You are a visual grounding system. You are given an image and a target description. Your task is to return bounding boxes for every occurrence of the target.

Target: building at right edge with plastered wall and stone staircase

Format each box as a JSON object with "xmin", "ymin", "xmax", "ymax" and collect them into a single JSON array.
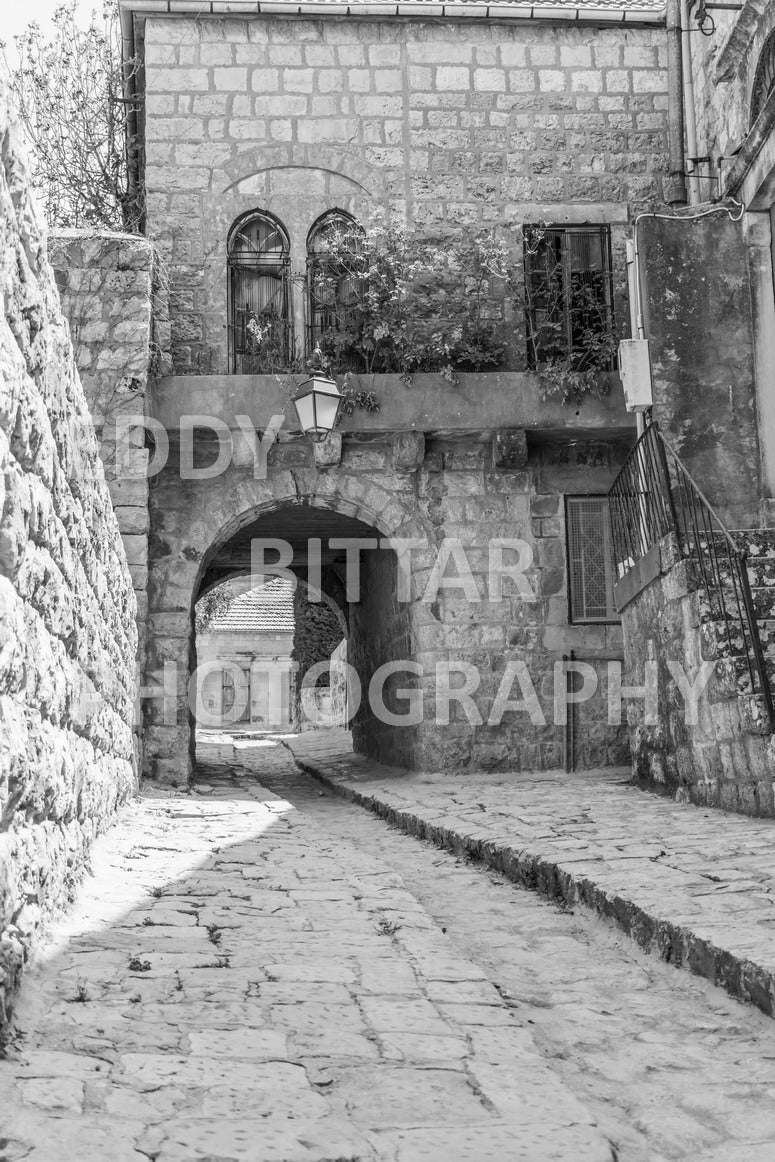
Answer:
[{"xmin": 616, "ymin": 0, "xmax": 775, "ymax": 815}]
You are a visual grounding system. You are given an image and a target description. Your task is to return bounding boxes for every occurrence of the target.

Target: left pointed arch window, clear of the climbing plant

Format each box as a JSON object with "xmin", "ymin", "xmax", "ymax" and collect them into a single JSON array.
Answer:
[{"xmin": 228, "ymin": 213, "xmax": 293, "ymax": 375}]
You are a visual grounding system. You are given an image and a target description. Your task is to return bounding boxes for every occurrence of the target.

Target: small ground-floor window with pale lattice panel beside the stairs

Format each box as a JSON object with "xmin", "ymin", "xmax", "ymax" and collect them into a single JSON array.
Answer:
[{"xmin": 565, "ymin": 496, "xmax": 618, "ymax": 624}]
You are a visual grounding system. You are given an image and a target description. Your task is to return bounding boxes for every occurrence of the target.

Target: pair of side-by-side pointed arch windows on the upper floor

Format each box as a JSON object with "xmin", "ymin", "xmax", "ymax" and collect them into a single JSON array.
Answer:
[{"xmin": 228, "ymin": 210, "xmax": 361, "ymax": 375}]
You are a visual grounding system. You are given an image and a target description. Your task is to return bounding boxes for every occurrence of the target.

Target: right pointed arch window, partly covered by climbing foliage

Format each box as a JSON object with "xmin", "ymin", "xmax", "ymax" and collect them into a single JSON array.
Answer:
[{"xmin": 307, "ymin": 210, "xmax": 367, "ymax": 371}]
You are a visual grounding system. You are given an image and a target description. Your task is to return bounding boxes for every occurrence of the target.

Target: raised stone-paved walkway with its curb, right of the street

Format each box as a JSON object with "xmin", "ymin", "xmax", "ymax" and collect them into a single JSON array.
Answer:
[{"xmin": 285, "ymin": 731, "xmax": 775, "ymax": 1016}]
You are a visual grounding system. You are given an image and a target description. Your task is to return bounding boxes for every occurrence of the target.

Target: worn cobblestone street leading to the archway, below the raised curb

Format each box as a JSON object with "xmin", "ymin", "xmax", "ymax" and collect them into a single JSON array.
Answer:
[{"xmin": 0, "ymin": 740, "xmax": 775, "ymax": 1162}]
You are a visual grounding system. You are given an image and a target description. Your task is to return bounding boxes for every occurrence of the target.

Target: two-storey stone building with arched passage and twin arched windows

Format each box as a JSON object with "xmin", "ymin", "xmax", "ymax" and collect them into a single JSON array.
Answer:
[{"xmin": 112, "ymin": 0, "xmax": 680, "ymax": 782}]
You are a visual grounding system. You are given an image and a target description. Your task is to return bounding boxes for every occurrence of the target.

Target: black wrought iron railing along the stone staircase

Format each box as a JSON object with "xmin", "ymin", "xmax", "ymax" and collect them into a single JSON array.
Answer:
[{"xmin": 609, "ymin": 424, "xmax": 775, "ymax": 724}]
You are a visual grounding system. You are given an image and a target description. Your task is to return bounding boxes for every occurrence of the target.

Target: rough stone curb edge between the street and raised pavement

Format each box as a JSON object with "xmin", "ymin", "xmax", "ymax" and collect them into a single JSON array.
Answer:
[{"xmin": 286, "ymin": 744, "xmax": 775, "ymax": 1017}]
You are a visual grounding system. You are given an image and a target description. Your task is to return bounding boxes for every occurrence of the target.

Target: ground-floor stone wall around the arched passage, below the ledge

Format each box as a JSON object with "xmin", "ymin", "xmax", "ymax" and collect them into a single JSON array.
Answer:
[{"xmin": 145, "ymin": 433, "xmax": 626, "ymax": 783}]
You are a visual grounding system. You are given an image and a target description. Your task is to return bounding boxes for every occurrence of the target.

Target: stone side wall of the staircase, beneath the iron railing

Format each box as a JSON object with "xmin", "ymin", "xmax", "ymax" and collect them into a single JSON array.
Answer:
[{"xmin": 623, "ymin": 538, "xmax": 775, "ymax": 816}]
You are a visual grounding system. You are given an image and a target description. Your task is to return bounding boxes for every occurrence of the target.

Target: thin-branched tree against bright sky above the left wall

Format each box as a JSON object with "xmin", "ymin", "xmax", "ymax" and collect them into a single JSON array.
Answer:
[{"xmin": 2, "ymin": 0, "xmax": 141, "ymax": 232}]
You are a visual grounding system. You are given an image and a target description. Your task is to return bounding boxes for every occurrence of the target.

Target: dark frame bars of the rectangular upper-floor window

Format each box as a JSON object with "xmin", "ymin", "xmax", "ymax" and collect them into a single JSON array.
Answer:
[{"xmin": 523, "ymin": 222, "xmax": 615, "ymax": 371}]
